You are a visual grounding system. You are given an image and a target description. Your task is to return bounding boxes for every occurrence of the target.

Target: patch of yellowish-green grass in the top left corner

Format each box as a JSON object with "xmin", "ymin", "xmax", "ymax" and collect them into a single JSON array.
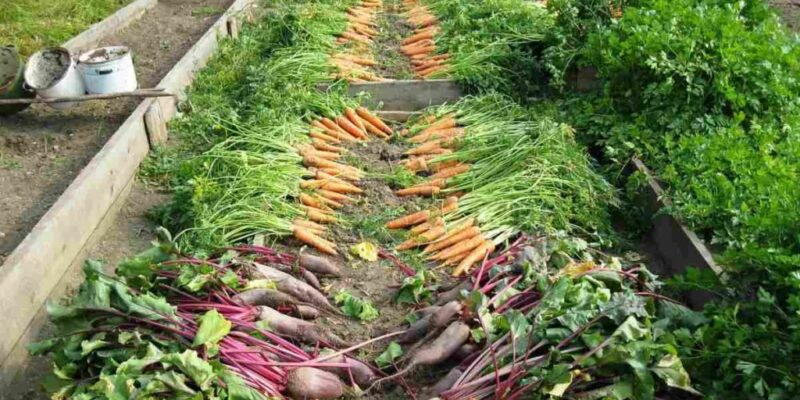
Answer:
[{"xmin": 0, "ymin": 0, "xmax": 132, "ymax": 57}]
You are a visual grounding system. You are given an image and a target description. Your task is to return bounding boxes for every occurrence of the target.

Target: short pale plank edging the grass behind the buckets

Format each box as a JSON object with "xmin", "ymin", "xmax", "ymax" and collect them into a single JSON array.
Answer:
[{"xmin": 63, "ymin": 0, "xmax": 158, "ymax": 53}]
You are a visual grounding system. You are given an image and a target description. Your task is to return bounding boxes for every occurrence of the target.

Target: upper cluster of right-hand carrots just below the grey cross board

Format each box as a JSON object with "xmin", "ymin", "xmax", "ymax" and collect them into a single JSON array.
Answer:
[{"xmin": 395, "ymin": 114, "xmax": 470, "ymax": 196}]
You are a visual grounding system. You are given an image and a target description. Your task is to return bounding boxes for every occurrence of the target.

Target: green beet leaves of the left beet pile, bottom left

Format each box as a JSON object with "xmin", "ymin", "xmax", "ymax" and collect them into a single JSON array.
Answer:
[{"xmin": 29, "ymin": 261, "xmax": 265, "ymax": 400}]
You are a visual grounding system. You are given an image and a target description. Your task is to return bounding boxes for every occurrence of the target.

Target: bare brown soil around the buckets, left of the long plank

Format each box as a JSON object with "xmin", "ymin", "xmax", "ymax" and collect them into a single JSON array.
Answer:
[{"xmin": 0, "ymin": 0, "xmax": 232, "ymax": 264}]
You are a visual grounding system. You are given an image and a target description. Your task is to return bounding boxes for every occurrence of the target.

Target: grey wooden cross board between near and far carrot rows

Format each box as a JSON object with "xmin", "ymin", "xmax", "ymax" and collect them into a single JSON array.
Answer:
[{"xmin": 320, "ymin": 79, "xmax": 462, "ymax": 111}]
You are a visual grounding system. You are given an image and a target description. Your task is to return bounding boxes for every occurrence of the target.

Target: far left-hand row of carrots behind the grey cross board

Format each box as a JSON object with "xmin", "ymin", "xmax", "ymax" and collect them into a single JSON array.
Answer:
[{"xmin": 330, "ymin": 0, "xmax": 387, "ymax": 82}]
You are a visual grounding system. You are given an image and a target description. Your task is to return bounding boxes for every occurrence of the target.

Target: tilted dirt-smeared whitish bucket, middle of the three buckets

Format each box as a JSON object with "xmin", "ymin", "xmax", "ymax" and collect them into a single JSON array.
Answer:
[{"xmin": 25, "ymin": 47, "xmax": 86, "ymax": 110}]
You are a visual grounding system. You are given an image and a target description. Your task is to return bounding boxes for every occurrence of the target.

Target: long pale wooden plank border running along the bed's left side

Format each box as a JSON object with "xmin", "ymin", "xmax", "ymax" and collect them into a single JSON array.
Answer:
[{"xmin": 0, "ymin": 0, "xmax": 256, "ymax": 393}]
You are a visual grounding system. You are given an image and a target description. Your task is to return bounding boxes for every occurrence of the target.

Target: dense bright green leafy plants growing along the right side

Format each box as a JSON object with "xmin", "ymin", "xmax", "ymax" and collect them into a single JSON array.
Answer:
[{"xmin": 546, "ymin": 0, "xmax": 800, "ymax": 399}]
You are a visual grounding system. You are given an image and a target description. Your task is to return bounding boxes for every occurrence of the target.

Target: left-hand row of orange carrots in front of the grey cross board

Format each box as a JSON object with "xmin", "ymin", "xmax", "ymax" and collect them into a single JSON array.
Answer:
[{"xmin": 292, "ymin": 107, "xmax": 392, "ymax": 255}]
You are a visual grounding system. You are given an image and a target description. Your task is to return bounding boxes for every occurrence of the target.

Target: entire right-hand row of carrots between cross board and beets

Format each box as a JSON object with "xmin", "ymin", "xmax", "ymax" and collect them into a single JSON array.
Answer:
[{"xmin": 386, "ymin": 114, "xmax": 494, "ymax": 276}]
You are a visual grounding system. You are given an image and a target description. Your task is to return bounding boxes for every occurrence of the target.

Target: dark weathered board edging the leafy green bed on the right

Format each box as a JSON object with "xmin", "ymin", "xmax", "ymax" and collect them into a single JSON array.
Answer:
[{"xmin": 632, "ymin": 158, "xmax": 724, "ymax": 309}]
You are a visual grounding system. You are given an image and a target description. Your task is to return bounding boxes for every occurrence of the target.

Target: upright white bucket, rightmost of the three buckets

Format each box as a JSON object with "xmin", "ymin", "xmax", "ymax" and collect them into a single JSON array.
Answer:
[{"xmin": 78, "ymin": 46, "xmax": 138, "ymax": 94}]
